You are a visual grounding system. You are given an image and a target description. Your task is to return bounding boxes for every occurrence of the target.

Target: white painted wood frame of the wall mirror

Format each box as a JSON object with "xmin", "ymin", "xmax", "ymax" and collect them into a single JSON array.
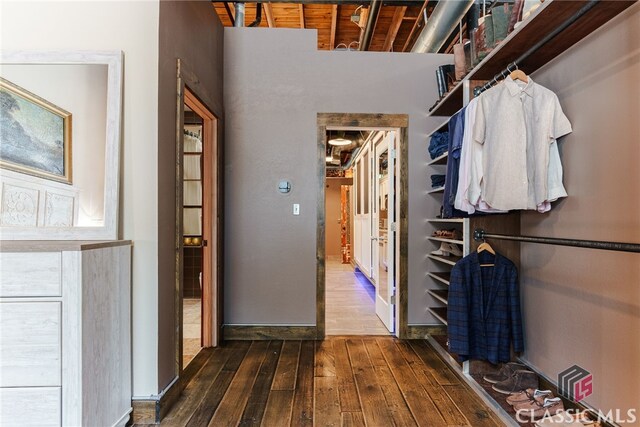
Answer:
[{"xmin": 0, "ymin": 51, "xmax": 124, "ymax": 240}]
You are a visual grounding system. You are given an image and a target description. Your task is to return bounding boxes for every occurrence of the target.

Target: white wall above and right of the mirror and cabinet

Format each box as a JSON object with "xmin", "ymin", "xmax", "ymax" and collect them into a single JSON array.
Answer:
[{"xmin": 0, "ymin": 1, "xmax": 159, "ymax": 396}]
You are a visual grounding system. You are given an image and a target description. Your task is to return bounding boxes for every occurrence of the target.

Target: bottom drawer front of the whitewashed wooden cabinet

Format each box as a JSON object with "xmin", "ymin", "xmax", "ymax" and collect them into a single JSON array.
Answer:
[{"xmin": 0, "ymin": 387, "xmax": 62, "ymax": 427}]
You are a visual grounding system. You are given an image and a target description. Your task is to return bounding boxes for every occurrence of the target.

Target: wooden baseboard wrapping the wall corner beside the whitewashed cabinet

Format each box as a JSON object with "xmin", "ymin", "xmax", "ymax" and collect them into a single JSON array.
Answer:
[{"xmin": 131, "ymin": 348, "xmax": 213, "ymax": 424}]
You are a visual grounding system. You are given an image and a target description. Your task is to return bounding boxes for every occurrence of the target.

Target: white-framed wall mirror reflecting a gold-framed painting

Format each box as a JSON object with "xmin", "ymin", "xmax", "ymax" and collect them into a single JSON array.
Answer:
[{"xmin": 0, "ymin": 51, "xmax": 123, "ymax": 240}]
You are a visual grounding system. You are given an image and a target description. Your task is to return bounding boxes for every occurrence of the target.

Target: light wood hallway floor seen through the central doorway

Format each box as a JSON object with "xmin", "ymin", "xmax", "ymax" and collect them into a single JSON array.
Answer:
[{"xmin": 325, "ymin": 257, "xmax": 389, "ymax": 335}]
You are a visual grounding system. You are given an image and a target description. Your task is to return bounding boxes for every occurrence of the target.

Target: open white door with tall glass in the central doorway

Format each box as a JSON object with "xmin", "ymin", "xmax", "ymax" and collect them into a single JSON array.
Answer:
[{"xmin": 371, "ymin": 132, "xmax": 396, "ymax": 333}]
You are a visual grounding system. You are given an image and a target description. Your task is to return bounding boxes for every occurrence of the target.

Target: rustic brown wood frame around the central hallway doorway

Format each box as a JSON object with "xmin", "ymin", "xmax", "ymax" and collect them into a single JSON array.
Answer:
[{"xmin": 316, "ymin": 113, "xmax": 409, "ymax": 339}]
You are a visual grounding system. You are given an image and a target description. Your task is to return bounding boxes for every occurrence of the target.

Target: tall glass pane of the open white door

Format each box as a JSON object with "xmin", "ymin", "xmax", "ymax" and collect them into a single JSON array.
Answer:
[{"xmin": 374, "ymin": 151, "xmax": 389, "ymax": 303}]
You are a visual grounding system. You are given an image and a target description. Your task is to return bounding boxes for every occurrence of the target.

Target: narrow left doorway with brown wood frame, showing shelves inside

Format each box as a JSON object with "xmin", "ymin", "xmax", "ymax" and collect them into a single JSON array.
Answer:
[{"xmin": 176, "ymin": 85, "xmax": 220, "ymax": 372}]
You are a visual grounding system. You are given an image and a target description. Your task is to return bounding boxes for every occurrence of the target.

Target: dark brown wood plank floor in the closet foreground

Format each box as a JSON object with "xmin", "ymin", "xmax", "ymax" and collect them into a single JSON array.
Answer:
[{"xmin": 145, "ymin": 336, "xmax": 502, "ymax": 427}]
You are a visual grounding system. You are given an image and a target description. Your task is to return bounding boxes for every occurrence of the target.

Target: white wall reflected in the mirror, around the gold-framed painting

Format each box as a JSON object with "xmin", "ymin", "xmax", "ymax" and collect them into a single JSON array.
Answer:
[{"xmin": 0, "ymin": 64, "xmax": 107, "ymax": 226}]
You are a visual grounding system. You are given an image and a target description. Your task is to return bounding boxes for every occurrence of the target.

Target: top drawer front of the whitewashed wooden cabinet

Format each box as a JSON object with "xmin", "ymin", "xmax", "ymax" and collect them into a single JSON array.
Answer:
[{"xmin": 0, "ymin": 252, "xmax": 62, "ymax": 297}]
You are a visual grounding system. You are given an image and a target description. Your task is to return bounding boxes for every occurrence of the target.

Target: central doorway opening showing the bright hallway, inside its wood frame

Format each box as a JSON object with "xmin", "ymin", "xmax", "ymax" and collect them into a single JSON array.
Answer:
[{"xmin": 325, "ymin": 129, "xmax": 398, "ymax": 335}]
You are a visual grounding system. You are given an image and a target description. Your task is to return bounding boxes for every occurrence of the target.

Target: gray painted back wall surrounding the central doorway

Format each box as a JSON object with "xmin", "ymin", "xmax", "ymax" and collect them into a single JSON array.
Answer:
[{"xmin": 224, "ymin": 28, "xmax": 451, "ymax": 325}]
